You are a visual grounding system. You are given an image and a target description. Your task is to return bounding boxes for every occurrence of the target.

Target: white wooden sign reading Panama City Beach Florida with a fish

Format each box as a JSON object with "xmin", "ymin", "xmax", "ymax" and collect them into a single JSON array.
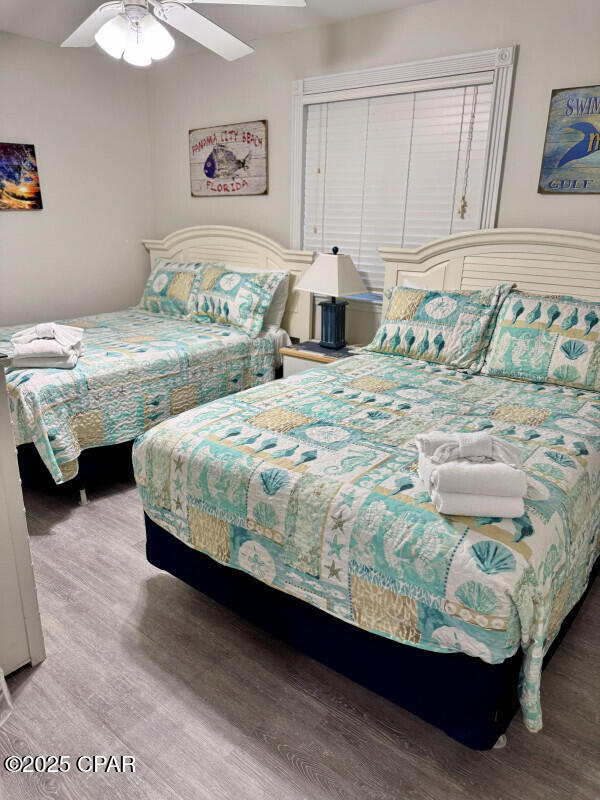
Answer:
[{"xmin": 189, "ymin": 119, "xmax": 269, "ymax": 197}]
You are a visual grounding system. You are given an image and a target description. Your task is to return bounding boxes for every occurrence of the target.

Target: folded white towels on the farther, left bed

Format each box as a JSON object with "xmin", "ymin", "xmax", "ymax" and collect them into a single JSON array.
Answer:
[{"xmin": 11, "ymin": 322, "xmax": 83, "ymax": 369}]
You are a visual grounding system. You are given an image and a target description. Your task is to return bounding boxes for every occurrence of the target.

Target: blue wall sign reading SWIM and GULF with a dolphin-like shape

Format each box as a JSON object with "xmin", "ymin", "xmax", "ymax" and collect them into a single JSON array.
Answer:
[{"xmin": 538, "ymin": 86, "xmax": 600, "ymax": 194}]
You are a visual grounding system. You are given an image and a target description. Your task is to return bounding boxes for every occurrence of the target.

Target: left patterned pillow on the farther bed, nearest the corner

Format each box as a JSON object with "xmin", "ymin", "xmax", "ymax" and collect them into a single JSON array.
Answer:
[{"xmin": 139, "ymin": 258, "xmax": 203, "ymax": 317}]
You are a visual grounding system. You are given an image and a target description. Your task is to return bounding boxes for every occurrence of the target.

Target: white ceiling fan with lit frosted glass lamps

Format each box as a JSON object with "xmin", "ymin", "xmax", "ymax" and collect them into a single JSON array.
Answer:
[{"xmin": 61, "ymin": 0, "xmax": 306, "ymax": 67}]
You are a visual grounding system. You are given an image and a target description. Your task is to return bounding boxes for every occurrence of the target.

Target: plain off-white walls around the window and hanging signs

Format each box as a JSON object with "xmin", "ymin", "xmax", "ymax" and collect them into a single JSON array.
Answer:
[{"xmin": 0, "ymin": 0, "xmax": 600, "ymax": 332}]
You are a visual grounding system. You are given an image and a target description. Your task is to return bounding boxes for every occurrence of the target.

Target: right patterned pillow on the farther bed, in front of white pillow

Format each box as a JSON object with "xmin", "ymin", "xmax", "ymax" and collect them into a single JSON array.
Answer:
[{"xmin": 194, "ymin": 264, "xmax": 289, "ymax": 335}]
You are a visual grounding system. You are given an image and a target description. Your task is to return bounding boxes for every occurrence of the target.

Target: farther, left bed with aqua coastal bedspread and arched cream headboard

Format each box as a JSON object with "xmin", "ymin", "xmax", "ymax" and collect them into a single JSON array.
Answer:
[{"xmin": 0, "ymin": 226, "xmax": 313, "ymax": 483}]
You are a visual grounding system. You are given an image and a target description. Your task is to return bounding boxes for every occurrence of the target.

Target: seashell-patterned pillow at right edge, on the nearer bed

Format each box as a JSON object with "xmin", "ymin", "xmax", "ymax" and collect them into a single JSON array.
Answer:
[{"xmin": 483, "ymin": 292, "xmax": 600, "ymax": 391}]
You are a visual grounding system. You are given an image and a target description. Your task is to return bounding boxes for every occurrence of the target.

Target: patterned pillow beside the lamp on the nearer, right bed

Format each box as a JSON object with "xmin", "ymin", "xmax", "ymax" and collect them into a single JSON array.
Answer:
[{"xmin": 366, "ymin": 283, "xmax": 514, "ymax": 372}]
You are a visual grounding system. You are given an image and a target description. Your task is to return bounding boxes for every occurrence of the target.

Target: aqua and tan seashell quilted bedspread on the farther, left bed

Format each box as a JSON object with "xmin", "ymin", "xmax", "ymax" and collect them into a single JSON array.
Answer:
[{"xmin": 0, "ymin": 309, "xmax": 274, "ymax": 483}]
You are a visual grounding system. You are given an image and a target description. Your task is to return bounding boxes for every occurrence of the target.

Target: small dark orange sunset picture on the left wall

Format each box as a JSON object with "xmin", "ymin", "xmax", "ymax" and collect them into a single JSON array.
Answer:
[{"xmin": 0, "ymin": 142, "xmax": 42, "ymax": 211}]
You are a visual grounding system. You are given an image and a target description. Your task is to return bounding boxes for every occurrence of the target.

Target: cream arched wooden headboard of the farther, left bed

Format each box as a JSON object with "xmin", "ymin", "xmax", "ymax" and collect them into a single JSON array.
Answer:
[{"xmin": 144, "ymin": 225, "xmax": 314, "ymax": 341}]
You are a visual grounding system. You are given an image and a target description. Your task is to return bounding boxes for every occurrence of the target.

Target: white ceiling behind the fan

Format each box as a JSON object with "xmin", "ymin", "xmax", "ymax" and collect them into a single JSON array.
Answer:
[{"xmin": 0, "ymin": 0, "xmax": 431, "ymax": 55}]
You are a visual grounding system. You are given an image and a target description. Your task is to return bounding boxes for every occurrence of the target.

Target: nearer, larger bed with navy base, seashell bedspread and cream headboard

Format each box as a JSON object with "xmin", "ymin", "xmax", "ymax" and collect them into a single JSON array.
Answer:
[{"xmin": 134, "ymin": 230, "xmax": 600, "ymax": 749}]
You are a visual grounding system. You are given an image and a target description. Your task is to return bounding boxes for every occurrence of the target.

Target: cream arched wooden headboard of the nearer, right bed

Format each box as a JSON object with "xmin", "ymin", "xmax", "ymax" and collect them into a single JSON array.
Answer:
[{"xmin": 379, "ymin": 228, "xmax": 600, "ymax": 313}]
